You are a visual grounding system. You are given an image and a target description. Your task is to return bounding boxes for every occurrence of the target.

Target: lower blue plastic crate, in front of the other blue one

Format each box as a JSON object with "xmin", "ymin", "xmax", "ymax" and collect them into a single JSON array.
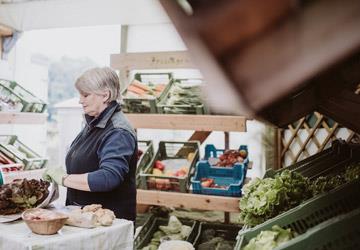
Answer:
[{"xmin": 191, "ymin": 161, "xmax": 246, "ymax": 197}]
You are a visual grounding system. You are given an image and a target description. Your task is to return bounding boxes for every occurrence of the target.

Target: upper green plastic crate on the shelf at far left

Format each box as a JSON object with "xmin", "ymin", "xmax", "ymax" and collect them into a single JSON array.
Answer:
[{"xmin": 0, "ymin": 79, "xmax": 46, "ymax": 113}]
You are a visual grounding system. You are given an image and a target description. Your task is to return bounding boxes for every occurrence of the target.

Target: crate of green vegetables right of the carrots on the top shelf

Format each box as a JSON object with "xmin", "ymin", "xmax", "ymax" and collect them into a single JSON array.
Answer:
[{"xmin": 157, "ymin": 79, "xmax": 207, "ymax": 114}]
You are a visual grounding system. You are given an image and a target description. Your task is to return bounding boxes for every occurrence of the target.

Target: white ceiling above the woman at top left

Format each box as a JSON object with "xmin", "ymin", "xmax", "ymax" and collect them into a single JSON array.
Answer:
[{"xmin": 0, "ymin": 0, "xmax": 170, "ymax": 31}]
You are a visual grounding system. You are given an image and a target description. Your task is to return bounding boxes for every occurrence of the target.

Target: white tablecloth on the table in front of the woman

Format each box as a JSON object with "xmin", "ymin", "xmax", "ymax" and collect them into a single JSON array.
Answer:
[{"xmin": 0, "ymin": 219, "xmax": 134, "ymax": 250}]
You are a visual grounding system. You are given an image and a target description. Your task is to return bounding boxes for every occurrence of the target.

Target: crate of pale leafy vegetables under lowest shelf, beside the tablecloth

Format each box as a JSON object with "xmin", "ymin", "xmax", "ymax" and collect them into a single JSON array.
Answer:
[{"xmin": 134, "ymin": 215, "xmax": 199, "ymax": 250}]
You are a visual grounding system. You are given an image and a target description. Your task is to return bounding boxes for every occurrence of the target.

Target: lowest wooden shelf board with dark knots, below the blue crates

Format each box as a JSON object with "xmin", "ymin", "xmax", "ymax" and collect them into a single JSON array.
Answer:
[{"xmin": 137, "ymin": 189, "xmax": 240, "ymax": 212}]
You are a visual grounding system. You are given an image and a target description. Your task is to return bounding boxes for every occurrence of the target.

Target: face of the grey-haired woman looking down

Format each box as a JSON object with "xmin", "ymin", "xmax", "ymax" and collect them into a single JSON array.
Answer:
[{"xmin": 79, "ymin": 92, "xmax": 108, "ymax": 117}]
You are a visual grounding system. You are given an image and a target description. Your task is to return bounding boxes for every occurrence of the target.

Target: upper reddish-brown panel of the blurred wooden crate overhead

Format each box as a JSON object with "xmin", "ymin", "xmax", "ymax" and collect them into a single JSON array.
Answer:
[{"xmin": 188, "ymin": 0, "xmax": 295, "ymax": 57}]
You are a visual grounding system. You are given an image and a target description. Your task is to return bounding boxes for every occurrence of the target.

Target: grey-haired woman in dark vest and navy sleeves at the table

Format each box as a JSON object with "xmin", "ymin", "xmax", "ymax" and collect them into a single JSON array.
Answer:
[{"xmin": 44, "ymin": 67, "xmax": 137, "ymax": 221}]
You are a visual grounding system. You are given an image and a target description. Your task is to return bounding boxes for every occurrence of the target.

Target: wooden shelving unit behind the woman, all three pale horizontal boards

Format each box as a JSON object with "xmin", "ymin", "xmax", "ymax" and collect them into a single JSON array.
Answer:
[{"xmin": 110, "ymin": 51, "xmax": 247, "ymax": 215}]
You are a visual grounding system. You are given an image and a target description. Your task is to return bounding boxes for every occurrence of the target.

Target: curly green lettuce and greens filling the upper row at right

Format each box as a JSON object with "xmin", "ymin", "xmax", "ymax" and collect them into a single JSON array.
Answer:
[{"xmin": 240, "ymin": 163, "xmax": 360, "ymax": 226}]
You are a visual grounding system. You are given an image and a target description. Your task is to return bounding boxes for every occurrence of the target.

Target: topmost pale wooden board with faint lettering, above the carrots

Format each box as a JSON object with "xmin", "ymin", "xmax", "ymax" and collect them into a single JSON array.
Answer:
[{"xmin": 110, "ymin": 51, "xmax": 195, "ymax": 70}]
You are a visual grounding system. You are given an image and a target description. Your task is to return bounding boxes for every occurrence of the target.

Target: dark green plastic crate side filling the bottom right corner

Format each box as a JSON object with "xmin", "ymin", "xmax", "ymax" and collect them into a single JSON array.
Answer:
[{"xmin": 276, "ymin": 208, "xmax": 360, "ymax": 250}]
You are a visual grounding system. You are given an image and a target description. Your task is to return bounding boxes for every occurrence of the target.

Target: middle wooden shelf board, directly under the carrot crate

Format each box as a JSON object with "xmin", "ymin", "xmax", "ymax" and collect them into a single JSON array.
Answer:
[{"xmin": 126, "ymin": 114, "xmax": 246, "ymax": 132}]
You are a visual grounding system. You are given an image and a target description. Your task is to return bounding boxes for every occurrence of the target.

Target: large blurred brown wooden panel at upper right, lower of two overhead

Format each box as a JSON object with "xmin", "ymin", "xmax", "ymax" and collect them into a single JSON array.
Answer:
[{"xmin": 228, "ymin": 0, "xmax": 360, "ymax": 110}]
